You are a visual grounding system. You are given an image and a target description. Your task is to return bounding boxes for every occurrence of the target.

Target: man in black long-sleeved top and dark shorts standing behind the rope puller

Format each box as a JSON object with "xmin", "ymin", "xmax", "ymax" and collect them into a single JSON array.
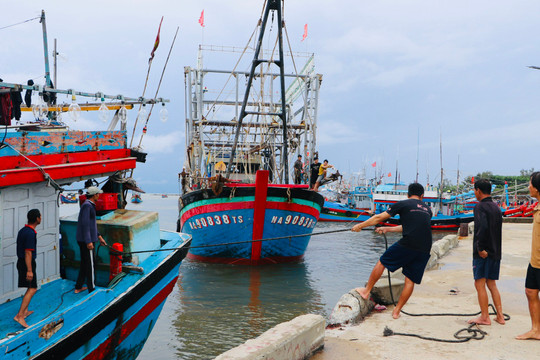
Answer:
[{"xmin": 469, "ymin": 179, "xmax": 505, "ymax": 325}]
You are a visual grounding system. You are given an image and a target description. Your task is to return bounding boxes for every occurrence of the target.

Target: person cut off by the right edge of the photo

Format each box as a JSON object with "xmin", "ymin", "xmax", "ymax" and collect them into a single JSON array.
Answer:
[{"xmin": 516, "ymin": 171, "xmax": 540, "ymax": 340}]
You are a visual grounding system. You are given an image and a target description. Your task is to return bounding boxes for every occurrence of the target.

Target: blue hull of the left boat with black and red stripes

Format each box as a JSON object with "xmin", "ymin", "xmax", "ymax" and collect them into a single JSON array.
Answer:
[{"xmin": 0, "ymin": 235, "xmax": 190, "ymax": 359}]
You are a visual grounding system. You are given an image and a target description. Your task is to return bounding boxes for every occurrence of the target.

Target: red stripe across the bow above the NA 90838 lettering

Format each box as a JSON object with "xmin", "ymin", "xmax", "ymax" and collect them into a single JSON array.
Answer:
[{"xmin": 180, "ymin": 201, "xmax": 319, "ymax": 226}]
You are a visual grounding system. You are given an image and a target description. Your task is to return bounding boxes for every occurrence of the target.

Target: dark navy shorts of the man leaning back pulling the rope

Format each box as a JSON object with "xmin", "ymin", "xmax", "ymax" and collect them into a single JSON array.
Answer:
[{"xmin": 379, "ymin": 243, "xmax": 431, "ymax": 284}]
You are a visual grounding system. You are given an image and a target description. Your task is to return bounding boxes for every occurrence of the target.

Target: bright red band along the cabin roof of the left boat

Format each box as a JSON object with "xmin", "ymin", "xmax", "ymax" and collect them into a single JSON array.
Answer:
[{"xmin": 0, "ymin": 158, "xmax": 136, "ymax": 187}]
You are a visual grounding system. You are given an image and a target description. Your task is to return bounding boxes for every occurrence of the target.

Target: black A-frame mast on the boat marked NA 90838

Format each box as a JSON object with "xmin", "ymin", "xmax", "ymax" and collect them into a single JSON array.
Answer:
[{"xmin": 225, "ymin": 0, "xmax": 289, "ymax": 184}]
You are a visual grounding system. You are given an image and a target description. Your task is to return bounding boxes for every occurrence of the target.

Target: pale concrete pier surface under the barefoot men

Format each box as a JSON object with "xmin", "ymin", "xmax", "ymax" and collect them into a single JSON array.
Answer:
[{"xmin": 311, "ymin": 222, "xmax": 540, "ymax": 360}]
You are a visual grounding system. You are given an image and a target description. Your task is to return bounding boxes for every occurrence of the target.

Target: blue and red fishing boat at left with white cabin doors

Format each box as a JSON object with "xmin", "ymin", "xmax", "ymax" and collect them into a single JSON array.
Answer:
[{"xmin": 0, "ymin": 12, "xmax": 190, "ymax": 360}]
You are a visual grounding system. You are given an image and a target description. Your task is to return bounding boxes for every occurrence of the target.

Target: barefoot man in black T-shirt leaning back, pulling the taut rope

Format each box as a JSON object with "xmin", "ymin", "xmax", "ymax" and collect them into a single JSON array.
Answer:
[{"xmin": 352, "ymin": 183, "xmax": 432, "ymax": 319}]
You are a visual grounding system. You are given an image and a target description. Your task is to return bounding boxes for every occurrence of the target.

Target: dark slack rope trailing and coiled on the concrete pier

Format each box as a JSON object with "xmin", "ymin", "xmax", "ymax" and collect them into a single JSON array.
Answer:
[{"xmin": 382, "ymin": 233, "xmax": 510, "ymax": 343}]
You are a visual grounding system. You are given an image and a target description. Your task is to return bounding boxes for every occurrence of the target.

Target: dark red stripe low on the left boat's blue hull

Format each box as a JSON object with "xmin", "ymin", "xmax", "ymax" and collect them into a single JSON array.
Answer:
[{"xmin": 84, "ymin": 276, "xmax": 178, "ymax": 360}]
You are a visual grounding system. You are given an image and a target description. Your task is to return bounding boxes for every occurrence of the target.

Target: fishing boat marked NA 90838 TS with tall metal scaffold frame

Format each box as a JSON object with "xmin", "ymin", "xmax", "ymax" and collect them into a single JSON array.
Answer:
[{"xmin": 177, "ymin": 0, "xmax": 324, "ymax": 265}]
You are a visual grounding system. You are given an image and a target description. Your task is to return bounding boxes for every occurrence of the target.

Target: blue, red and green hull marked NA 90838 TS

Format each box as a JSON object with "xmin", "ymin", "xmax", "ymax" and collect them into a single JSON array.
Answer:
[{"xmin": 178, "ymin": 186, "xmax": 324, "ymax": 265}]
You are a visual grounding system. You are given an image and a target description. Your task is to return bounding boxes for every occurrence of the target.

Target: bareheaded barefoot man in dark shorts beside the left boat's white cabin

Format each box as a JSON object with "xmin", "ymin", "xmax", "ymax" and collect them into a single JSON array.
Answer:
[{"xmin": 13, "ymin": 209, "xmax": 41, "ymax": 328}]
